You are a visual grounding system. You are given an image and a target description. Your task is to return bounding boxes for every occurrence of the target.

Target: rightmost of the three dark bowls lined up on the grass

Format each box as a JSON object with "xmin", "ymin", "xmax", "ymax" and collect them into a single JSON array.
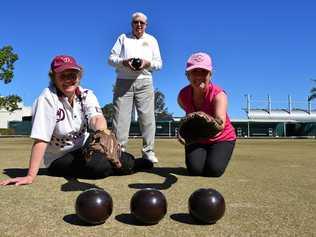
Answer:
[{"xmin": 189, "ymin": 188, "xmax": 225, "ymax": 224}]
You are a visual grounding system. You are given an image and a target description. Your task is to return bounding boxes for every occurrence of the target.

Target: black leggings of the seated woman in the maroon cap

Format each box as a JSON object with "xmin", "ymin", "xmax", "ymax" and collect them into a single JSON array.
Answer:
[{"xmin": 48, "ymin": 149, "xmax": 135, "ymax": 179}]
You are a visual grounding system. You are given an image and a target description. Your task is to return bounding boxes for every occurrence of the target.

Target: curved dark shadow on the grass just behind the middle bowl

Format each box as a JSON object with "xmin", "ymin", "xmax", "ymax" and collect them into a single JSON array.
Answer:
[{"xmin": 128, "ymin": 167, "xmax": 188, "ymax": 190}]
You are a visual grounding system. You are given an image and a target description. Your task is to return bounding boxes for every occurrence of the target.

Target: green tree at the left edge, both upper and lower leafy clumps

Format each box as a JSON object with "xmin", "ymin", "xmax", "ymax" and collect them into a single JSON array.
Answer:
[{"xmin": 0, "ymin": 46, "xmax": 22, "ymax": 112}]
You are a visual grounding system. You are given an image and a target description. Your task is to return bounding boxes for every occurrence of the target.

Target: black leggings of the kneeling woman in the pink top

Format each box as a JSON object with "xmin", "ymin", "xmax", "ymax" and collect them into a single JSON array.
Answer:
[{"xmin": 185, "ymin": 141, "xmax": 235, "ymax": 177}]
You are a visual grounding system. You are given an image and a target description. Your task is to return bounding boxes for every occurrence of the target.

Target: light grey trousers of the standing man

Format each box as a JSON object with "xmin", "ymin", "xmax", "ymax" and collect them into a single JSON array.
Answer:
[{"xmin": 113, "ymin": 79, "xmax": 156, "ymax": 152}]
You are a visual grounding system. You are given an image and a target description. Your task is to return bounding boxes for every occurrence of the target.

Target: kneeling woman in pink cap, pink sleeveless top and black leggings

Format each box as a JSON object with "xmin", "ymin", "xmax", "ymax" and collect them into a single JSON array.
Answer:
[{"xmin": 178, "ymin": 52, "xmax": 236, "ymax": 177}]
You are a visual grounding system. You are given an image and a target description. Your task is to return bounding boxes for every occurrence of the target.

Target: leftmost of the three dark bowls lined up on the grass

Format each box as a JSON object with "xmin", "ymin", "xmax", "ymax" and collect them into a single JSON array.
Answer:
[{"xmin": 75, "ymin": 188, "xmax": 113, "ymax": 225}]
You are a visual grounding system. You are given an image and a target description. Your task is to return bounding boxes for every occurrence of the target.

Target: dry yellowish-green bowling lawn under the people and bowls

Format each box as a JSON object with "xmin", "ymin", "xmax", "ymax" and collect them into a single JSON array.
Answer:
[{"xmin": 0, "ymin": 138, "xmax": 316, "ymax": 237}]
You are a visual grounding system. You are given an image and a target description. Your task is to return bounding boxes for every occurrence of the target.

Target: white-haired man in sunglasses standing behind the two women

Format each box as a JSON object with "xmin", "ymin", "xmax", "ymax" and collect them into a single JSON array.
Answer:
[{"xmin": 109, "ymin": 12, "xmax": 162, "ymax": 163}]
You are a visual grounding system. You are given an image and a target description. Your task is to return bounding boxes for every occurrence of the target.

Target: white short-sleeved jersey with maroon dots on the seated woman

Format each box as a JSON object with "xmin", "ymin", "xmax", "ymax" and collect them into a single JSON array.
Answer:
[{"xmin": 31, "ymin": 85, "xmax": 102, "ymax": 167}]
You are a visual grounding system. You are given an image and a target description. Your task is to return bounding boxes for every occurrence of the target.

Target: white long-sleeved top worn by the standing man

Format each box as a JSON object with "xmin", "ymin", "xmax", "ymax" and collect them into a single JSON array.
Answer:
[{"xmin": 109, "ymin": 33, "xmax": 162, "ymax": 80}]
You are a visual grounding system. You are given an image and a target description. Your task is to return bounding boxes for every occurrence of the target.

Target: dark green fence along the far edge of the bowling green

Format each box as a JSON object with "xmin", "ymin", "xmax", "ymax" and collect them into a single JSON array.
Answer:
[{"xmin": 4, "ymin": 121, "xmax": 316, "ymax": 137}]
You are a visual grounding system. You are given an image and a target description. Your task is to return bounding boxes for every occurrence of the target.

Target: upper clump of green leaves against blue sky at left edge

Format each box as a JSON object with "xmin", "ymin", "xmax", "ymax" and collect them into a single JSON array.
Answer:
[{"xmin": 0, "ymin": 46, "xmax": 19, "ymax": 84}]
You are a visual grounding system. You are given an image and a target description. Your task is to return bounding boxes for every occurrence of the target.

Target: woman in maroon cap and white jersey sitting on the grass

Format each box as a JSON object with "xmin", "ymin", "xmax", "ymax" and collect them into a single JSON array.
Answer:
[{"xmin": 0, "ymin": 55, "xmax": 151, "ymax": 185}]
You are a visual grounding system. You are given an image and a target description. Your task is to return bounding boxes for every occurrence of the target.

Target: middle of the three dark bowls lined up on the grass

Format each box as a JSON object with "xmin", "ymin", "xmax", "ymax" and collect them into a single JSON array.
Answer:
[{"xmin": 130, "ymin": 189, "xmax": 167, "ymax": 225}]
